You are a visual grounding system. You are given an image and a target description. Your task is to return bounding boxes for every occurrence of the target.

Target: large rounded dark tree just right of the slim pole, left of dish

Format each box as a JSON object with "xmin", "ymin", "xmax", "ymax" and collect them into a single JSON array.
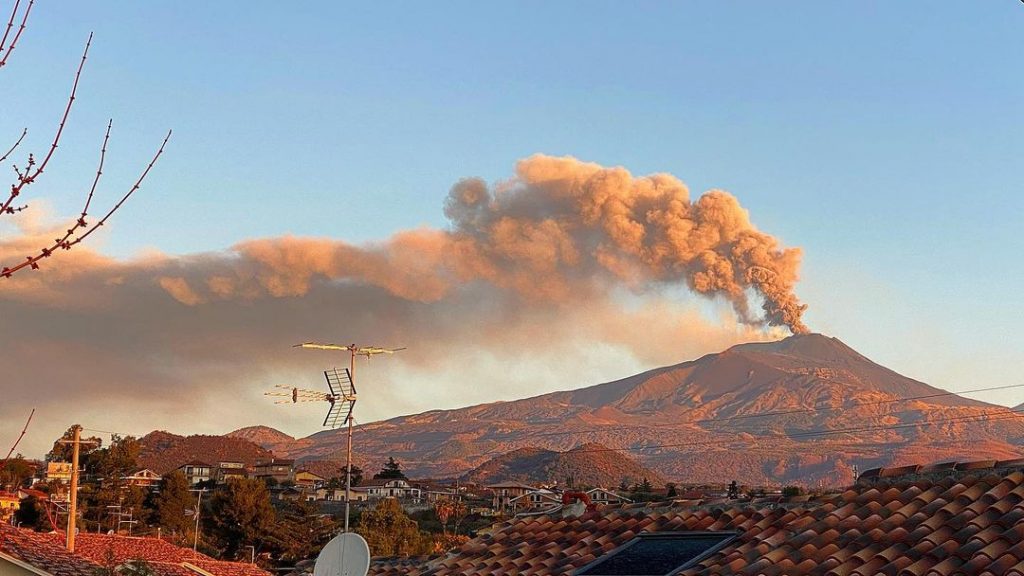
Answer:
[{"xmin": 203, "ymin": 478, "xmax": 278, "ymax": 558}]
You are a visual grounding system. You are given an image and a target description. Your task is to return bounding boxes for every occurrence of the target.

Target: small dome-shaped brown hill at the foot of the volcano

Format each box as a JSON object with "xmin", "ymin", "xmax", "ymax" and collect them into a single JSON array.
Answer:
[{"xmin": 464, "ymin": 444, "xmax": 666, "ymax": 488}]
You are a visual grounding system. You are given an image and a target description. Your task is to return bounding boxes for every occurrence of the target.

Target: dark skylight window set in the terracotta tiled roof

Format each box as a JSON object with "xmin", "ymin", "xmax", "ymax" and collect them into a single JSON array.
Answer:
[{"xmin": 575, "ymin": 532, "xmax": 736, "ymax": 576}]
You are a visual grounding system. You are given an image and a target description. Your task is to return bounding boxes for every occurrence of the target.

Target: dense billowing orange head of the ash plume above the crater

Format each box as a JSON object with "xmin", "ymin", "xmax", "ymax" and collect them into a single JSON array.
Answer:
[{"xmin": 444, "ymin": 156, "xmax": 808, "ymax": 333}]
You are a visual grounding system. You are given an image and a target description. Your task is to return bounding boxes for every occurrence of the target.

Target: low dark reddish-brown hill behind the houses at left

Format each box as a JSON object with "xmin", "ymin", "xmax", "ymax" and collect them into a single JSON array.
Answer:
[{"xmin": 138, "ymin": 430, "xmax": 273, "ymax": 475}]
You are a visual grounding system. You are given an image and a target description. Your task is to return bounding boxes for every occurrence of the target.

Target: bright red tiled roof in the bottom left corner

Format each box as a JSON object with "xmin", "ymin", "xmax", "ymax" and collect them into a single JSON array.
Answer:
[{"xmin": 0, "ymin": 525, "xmax": 269, "ymax": 576}]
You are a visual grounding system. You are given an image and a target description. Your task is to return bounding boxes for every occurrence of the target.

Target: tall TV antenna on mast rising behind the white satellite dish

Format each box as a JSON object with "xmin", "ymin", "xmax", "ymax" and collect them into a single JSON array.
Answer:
[{"xmin": 274, "ymin": 342, "xmax": 406, "ymax": 532}]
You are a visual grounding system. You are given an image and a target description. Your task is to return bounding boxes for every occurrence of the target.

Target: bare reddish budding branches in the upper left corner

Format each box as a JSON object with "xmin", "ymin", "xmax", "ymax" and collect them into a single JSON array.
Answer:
[{"xmin": 0, "ymin": 1, "xmax": 171, "ymax": 279}]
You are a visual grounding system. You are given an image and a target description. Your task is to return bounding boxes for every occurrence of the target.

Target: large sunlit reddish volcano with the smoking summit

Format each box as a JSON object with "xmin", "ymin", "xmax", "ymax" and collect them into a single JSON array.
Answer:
[{"xmin": 251, "ymin": 334, "xmax": 1024, "ymax": 485}]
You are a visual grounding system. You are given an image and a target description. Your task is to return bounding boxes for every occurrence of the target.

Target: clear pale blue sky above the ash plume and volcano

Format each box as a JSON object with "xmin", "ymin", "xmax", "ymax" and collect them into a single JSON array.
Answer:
[{"xmin": 0, "ymin": 0, "xmax": 1024, "ymax": 453}]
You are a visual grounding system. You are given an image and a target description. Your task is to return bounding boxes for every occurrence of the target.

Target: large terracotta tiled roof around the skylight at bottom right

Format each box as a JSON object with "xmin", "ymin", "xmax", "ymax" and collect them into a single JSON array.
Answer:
[{"xmin": 371, "ymin": 457, "xmax": 1024, "ymax": 576}]
